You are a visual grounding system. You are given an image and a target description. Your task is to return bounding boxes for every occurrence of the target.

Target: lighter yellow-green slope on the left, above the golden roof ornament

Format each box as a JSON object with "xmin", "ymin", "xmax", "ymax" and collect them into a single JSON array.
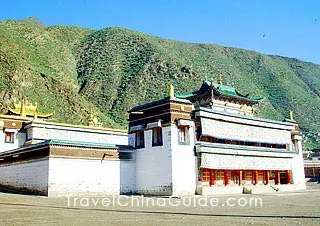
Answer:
[{"xmin": 0, "ymin": 20, "xmax": 118, "ymax": 127}]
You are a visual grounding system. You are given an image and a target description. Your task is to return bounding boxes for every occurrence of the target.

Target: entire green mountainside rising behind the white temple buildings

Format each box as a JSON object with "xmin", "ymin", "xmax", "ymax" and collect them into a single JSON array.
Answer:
[{"xmin": 0, "ymin": 18, "xmax": 320, "ymax": 147}]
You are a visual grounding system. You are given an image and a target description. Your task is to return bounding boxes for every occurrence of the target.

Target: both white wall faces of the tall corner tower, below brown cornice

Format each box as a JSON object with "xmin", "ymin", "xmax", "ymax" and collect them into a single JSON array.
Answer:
[{"xmin": 131, "ymin": 125, "xmax": 197, "ymax": 196}]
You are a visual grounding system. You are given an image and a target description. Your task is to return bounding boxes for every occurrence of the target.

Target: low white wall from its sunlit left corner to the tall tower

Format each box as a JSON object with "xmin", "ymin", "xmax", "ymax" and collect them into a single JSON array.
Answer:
[{"xmin": 49, "ymin": 157, "xmax": 135, "ymax": 197}]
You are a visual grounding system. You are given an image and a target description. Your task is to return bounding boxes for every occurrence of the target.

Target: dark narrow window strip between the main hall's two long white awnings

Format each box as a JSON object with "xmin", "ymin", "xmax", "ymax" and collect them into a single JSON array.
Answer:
[{"xmin": 200, "ymin": 136, "xmax": 288, "ymax": 149}]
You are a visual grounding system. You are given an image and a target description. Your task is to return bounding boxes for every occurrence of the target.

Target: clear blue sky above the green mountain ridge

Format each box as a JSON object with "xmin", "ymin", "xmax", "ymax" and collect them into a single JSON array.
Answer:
[{"xmin": 0, "ymin": 0, "xmax": 320, "ymax": 64}]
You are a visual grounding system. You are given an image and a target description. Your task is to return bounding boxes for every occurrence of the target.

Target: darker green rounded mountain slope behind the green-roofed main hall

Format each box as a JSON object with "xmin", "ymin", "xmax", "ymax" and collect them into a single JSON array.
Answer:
[{"xmin": 77, "ymin": 28, "xmax": 320, "ymax": 134}]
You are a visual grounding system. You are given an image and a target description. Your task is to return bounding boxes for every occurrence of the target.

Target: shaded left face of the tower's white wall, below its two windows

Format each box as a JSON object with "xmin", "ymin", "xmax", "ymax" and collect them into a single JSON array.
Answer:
[{"xmin": 135, "ymin": 127, "xmax": 172, "ymax": 195}]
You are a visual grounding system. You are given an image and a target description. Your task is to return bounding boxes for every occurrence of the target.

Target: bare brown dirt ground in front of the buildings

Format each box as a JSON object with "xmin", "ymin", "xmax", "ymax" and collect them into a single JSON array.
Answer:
[{"xmin": 0, "ymin": 184, "xmax": 320, "ymax": 226}]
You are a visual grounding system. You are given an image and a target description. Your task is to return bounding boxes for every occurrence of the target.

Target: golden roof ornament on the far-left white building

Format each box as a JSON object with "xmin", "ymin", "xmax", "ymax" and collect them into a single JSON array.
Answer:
[{"xmin": 8, "ymin": 98, "xmax": 53, "ymax": 119}]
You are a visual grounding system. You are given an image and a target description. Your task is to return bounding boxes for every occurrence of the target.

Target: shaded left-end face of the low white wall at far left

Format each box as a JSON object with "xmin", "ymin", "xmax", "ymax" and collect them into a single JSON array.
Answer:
[{"xmin": 0, "ymin": 159, "xmax": 49, "ymax": 194}]
